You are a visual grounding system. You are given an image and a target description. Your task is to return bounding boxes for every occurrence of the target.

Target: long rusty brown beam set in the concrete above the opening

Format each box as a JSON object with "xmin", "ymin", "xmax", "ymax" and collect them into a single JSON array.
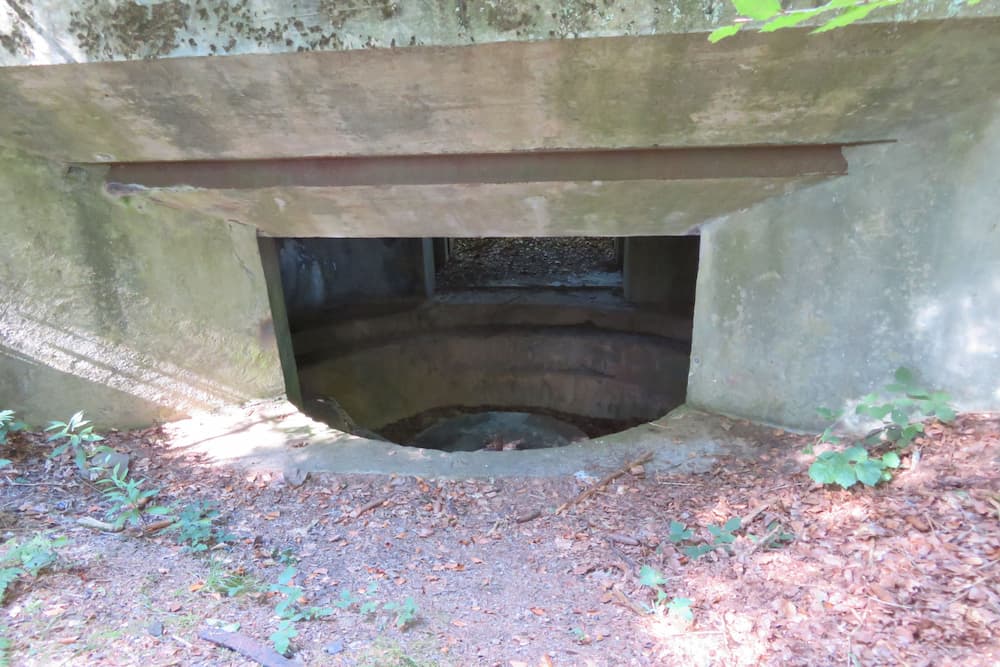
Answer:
[{"xmin": 106, "ymin": 145, "xmax": 847, "ymax": 189}]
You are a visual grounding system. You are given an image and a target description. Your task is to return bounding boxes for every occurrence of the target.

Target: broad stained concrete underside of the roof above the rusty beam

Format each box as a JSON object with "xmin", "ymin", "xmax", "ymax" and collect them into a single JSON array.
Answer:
[{"xmin": 0, "ymin": 20, "xmax": 1000, "ymax": 162}]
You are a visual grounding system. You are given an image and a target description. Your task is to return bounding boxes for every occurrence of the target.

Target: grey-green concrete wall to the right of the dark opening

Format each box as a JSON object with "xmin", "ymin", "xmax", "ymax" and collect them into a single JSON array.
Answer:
[{"xmin": 688, "ymin": 104, "xmax": 1000, "ymax": 428}]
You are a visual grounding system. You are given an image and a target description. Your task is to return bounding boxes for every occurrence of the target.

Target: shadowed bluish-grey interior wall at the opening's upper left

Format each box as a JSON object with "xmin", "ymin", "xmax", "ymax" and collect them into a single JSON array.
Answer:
[{"xmin": 277, "ymin": 238, "xmax": 428, "ymax": 327}]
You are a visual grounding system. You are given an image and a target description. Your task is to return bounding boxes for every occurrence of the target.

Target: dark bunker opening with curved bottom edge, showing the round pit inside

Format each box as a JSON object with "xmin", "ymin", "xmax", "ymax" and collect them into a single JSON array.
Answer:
[{"xmin": 277, "ymin": 236, "xmax": 699, "ymax": 451}]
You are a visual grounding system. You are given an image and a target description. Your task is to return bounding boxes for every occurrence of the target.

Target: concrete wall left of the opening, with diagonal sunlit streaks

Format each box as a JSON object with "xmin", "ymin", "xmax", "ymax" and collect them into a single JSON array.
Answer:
[{"xmin": 0, "ymin": 150, "xmax": 283, "ymax": 426}]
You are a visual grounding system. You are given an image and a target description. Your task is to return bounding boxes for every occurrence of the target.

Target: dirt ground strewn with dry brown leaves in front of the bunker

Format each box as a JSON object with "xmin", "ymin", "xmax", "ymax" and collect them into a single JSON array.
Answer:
[{"xmin": 0, "ymin": 415, "xmax": 1000, "ymax": 667}]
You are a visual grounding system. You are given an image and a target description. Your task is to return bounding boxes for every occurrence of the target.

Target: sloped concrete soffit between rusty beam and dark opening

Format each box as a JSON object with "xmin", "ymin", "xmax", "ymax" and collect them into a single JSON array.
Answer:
[{"xmin": 128, "ymin": 176, "xmax": 839, "ymax": 237}]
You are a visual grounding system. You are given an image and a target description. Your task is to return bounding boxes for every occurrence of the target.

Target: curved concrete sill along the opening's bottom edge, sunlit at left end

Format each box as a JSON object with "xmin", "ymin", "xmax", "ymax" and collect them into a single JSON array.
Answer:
[{"xmin": 164, "ymin": 401, "xmax": 769, "ymax": 484}]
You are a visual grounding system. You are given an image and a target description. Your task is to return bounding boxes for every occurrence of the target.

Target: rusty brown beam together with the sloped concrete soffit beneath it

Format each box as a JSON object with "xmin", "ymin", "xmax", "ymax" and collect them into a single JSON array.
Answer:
[{"xmin": 106, "ymin": 146, "xmax": 847, "ymax": 237}]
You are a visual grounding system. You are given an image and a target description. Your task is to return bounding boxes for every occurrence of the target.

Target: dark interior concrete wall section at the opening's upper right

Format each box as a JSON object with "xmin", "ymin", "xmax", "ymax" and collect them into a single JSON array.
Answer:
[{"xmin": 622, "ymin": 236, "xmax": 700, "ymax": 312}]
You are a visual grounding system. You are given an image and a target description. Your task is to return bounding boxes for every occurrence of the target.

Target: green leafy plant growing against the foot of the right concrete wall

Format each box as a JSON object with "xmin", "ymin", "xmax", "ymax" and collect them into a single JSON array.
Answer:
[{"xmin": 809, "ymin": 368, "xmax": 955, "ymax": 489}]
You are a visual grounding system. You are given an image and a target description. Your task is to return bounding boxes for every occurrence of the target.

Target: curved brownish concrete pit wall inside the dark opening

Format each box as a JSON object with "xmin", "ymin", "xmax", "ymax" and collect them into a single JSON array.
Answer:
[{"xmin": 295, "ymin": 293, "xmax": 691, "ymax": 448}]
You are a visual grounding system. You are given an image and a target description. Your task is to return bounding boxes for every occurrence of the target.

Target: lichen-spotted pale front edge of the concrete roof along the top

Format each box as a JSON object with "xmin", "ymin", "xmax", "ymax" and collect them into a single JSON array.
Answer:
[{"xmin": 0, "ymin": 0, "xmax": 996, "ymax": 65}]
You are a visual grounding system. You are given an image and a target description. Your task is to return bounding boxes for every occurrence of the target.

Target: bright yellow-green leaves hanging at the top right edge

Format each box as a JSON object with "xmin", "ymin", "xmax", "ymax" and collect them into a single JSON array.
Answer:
[{"xmin": 708, "ymin": 0, "xmax": 981, "ymax": 43}]
